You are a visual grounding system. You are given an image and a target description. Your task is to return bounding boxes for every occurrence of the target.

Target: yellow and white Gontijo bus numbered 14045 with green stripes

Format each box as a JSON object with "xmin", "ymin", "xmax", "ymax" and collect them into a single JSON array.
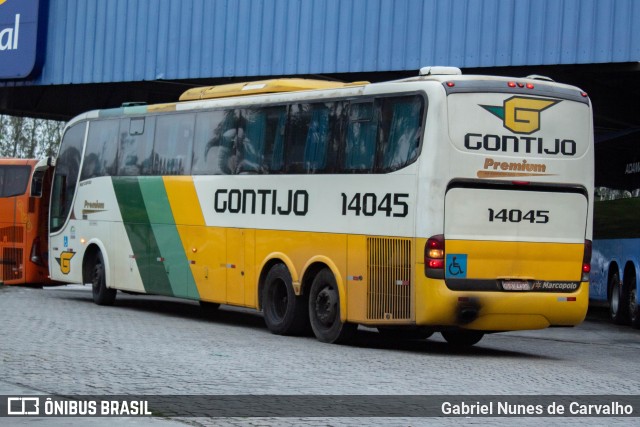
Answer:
[{"xmin": 49, "ymin": 67, "xmax": 593, "ymax": 345}]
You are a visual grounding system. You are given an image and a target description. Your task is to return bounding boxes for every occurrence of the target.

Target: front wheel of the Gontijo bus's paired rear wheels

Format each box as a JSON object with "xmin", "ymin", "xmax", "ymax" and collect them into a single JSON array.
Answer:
[{"xmin": 263, "ymin": 264, "xmax": 309, "ymax": 335}]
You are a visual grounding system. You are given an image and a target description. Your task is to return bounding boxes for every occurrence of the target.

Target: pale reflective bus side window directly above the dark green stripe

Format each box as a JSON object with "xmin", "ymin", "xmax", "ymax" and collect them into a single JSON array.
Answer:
[{"xmin": 118, "ymin": 117, "xmax": 156, "ymax": 176}]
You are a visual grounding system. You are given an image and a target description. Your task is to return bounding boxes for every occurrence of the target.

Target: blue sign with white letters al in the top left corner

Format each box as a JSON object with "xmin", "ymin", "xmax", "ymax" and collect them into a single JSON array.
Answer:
[{"xmin": 0, "ymin": 0, "xmax": 40, "ymax": 79}]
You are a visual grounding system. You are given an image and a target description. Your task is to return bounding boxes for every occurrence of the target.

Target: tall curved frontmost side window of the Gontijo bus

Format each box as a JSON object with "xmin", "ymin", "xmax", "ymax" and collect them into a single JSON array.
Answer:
[{"xmin": 50, "ymin": 123, "xmax": 85, "ymax": 232}]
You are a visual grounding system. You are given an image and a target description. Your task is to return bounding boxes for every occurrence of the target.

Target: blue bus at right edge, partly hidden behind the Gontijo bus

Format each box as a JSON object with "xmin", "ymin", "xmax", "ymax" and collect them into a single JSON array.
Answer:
[{"xmin": 590, "ymin": 131, "xmax": 640, "ymax": 329}]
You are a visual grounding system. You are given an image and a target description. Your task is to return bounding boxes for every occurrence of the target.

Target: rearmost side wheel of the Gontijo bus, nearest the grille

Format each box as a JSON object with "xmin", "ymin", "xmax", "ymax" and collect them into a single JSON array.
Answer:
[{"xmin": 309, "ymin": 268, "xmax": 358, "ymax": 344}]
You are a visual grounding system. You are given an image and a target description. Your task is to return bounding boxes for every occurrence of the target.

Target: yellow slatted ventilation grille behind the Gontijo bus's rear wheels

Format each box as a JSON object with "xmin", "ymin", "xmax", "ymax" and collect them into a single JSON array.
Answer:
[{"xmin": 367, "ymin": 237, "xmax": 413, "ymax": 320}]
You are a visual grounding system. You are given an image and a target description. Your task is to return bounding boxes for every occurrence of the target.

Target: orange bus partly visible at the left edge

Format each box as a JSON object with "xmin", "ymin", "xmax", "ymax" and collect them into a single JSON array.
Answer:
[{"xmin": 0, "ymin": 158, "xmax": 53, "ymax": 285}]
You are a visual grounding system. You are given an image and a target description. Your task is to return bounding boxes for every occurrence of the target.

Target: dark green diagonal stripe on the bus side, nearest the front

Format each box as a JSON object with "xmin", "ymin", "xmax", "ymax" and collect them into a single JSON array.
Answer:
[{"xmin": 112, "ymin": 177, "xmax": 173, "ymax": 296}]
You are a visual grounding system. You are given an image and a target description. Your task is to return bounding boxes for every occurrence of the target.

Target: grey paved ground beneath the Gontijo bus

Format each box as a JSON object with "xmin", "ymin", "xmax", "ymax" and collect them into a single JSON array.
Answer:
[{"xmin": 0, "ymin": 286, "xmax": 640, "ymax": 425}]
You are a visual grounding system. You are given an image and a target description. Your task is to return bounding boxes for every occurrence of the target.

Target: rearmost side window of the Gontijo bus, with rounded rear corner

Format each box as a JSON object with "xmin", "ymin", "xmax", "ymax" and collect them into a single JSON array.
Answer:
[{"xmin": 381, "ymin": 96, "xmax": 422, "ymax": 171}]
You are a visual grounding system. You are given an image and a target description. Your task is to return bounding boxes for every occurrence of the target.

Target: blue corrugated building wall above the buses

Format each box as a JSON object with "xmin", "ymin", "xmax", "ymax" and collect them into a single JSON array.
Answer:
[{"xmin": 8, "ymin": 0, "xmax": 640, "ymax": 86}]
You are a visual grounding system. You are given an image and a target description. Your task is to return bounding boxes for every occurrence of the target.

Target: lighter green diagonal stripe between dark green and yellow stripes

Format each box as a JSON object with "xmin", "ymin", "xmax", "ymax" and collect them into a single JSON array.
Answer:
[{"xmin": 139, "ymin": 177, "xmax": 199, "ymax": 299}]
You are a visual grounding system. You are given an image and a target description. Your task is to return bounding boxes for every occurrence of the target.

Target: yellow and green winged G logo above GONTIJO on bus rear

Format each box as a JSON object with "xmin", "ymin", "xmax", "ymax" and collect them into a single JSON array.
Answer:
[{"xmin": 480, "ymin": 96, "xmax": 560, "ymax": 135}]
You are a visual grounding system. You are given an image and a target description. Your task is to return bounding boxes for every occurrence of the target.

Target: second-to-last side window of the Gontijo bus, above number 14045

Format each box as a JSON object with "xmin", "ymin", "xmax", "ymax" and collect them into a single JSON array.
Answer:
[{"xmin": 344, "ymin": 102, "xmax": 378, "ymax": 172}]
